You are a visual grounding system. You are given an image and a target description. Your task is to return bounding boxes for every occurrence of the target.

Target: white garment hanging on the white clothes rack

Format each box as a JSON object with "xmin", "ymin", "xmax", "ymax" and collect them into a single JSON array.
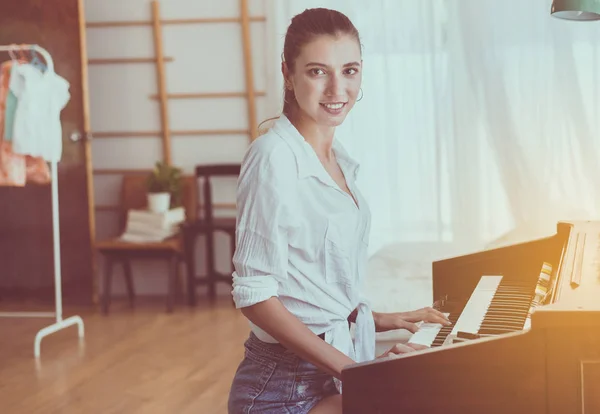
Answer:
[{"xmin": 10, "ymin": 64, "xmax": 71, "ymax": 162}]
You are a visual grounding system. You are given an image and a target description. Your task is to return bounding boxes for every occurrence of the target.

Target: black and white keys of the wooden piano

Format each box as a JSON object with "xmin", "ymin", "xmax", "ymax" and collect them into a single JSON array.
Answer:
[{"xmin": 408, "ymin": 276, "xmax": 532, "ymax": 347}]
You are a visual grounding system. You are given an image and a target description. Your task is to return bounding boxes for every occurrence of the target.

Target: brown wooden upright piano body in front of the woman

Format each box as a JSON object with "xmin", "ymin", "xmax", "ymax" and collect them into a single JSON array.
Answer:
[{"xmin": 342, "ymin": 222, "xmax": 600, "ymax": 414}]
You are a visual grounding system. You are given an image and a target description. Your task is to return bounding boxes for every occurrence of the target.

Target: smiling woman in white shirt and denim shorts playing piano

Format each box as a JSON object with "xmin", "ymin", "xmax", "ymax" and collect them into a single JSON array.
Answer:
[{"xmin": 229, "ymin": 9, "xmax": 448, "ymax": 414}]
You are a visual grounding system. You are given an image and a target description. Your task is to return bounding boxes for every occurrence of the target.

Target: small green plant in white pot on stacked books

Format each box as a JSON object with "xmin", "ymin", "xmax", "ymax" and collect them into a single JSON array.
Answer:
[{"xmin": 147, "ymin": 162, "xmax": 182, "ymax": 213}]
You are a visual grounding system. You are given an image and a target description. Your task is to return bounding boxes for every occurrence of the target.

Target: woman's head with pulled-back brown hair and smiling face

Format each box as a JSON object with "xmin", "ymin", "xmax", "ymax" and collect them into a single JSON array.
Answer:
[{"xmin": 281, "ymin": 9, "xmax": 362, "ymax": 127}]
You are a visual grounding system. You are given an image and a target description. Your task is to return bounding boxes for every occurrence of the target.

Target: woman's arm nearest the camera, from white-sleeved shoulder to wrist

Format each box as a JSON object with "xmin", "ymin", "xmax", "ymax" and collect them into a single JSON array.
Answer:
[{"xmin": 232, "ymin": 150, "xmax": 354, "ymax": 378}]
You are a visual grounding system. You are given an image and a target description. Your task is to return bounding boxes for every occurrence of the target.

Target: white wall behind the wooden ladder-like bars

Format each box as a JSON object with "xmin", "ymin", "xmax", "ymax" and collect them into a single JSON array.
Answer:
[{"xmin": 85, "ymin": 0, "xmax": 272, "ymax": 298}]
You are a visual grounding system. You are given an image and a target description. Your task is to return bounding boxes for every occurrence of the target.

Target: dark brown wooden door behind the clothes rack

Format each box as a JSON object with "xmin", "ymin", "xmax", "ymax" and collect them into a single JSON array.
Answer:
[{"xmin": 0, "ymin": 0, "xmax": 94, "ymax": 304}]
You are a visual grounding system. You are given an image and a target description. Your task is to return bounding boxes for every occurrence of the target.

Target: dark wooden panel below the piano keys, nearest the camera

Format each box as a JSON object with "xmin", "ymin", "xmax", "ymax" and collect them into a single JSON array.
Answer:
[{"xmin": 342, "ymin": 332, "xmax": 546, "ymax": 414}]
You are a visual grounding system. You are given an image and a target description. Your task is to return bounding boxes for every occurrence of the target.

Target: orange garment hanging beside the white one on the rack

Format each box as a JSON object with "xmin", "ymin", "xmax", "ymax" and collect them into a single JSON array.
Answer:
[{"xmin": 0, "ymin": 60, "xmax": 50, "ymax": 187}]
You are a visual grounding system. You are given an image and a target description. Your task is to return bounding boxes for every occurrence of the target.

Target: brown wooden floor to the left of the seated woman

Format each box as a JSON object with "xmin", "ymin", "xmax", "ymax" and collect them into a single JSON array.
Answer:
[{"xmin": 0, "ymin": 300, "xmax": 249, "ymax": 414}]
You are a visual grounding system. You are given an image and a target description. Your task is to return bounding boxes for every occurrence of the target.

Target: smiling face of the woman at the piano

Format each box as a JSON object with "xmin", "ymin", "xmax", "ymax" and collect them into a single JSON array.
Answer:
[{"xmin": 284, "ymin": 35, "xmax": 362, "ymax": 127}]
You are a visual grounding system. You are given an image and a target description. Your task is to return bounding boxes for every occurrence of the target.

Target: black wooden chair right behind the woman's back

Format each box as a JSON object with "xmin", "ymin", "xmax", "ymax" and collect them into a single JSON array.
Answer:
[{"xmin": 182, "ymin": 164, "xmax": 241, "ymax": 306}]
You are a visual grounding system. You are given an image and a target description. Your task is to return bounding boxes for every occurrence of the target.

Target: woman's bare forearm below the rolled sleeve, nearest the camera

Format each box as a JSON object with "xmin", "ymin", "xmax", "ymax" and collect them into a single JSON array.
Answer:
[{"xmin": 241, "ymin": 297, "xmax": 355, "ymax": 379}]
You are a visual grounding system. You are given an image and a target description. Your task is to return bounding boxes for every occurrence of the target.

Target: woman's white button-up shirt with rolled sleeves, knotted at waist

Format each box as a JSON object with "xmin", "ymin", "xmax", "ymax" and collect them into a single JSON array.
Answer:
[{"xmin": 232, "ymin": 115, "xmax": 375, "ymax": 362}]
